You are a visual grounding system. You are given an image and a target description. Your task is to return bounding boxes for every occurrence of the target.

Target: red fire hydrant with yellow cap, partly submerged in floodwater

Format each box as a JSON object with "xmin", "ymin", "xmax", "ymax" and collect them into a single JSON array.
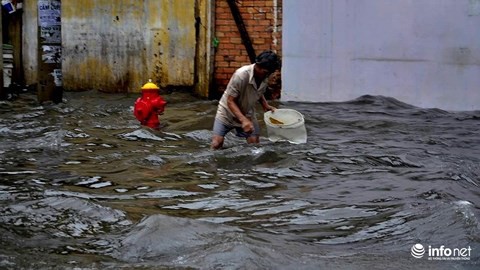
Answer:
[{"xmin": 133, "ymin": 80, "xmax": 167, "ymax": 129}]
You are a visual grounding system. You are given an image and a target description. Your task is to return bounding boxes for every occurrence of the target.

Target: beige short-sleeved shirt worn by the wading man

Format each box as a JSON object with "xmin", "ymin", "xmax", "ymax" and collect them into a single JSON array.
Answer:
[{"xmin": 216, "ymin": 64, "xmax": 267, "ymax": 127}]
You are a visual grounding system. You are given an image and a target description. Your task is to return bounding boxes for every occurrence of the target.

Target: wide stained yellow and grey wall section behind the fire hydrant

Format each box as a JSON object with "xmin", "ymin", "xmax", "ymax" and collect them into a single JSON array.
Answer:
[{"xmin": 62, "ymin": 0, "xmax": 199, "ymax": 92}]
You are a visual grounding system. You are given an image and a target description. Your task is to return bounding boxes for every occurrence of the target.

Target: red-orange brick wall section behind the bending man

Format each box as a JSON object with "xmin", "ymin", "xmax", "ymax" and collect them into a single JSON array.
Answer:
[{"xmin": 211, "ymin": 0, "xmax": 282, "ymax": 98}]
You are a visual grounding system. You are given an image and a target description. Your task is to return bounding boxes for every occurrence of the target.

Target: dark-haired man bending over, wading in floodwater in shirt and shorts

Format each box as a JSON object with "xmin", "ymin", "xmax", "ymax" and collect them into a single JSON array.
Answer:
[{"xmin": 212, "ymin": 51, "xmax": 280, "ymax": 149}]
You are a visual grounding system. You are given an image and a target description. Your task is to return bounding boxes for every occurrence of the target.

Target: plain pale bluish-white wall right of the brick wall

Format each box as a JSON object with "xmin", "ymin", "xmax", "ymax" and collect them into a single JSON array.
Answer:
[{"xmin": 282, "ymin": 0, "xmax": 480, "ymax": 110}]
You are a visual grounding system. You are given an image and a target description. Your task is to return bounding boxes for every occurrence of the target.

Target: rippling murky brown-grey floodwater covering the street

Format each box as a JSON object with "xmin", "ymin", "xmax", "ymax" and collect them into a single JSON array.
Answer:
[{"xmin": 0, "ymin": 91, "xmax": 480, "ymax": 269}]
